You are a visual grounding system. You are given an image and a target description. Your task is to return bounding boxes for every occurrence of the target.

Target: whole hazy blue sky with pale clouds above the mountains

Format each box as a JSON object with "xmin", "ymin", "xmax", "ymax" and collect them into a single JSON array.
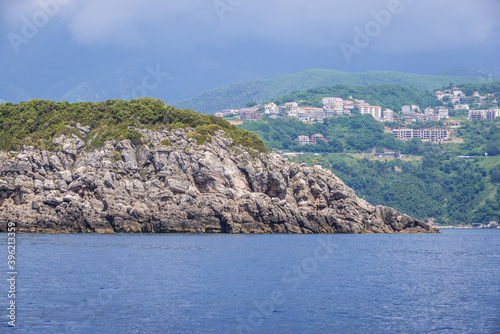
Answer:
[{"xmin": 0, "ymin": 0, "xmax": 500, "ymax": 100}]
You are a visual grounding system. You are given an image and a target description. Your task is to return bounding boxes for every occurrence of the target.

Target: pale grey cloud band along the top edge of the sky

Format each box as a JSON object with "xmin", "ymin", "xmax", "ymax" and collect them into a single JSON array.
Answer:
[{"xmin": 0, "ymin": 0, "xmax": 500, "ymax": 53}]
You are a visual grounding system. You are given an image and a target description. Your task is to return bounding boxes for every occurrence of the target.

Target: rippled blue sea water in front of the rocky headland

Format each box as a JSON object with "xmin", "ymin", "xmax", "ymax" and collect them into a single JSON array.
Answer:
[{"xmin": 0, "ymin": 229, "xmax": 500, "ymax": 333}]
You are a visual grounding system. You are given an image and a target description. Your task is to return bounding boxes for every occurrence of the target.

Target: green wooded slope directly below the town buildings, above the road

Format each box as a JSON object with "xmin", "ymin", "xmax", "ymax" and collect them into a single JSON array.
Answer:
[{"xmin": 240, "ymin": 114, "xmax": 500, "ymax": 156}]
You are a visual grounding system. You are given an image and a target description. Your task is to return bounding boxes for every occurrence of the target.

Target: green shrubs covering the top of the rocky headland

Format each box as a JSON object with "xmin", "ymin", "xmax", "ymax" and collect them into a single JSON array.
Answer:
[{"xmin": 0, "ymin": 98, "xmax": 267, "ymax": 152}]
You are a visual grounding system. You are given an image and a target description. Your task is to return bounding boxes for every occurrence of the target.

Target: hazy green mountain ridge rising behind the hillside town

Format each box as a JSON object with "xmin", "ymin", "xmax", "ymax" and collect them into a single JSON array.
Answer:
[{"xmin": 175, "ymin": 69, "xmax": 485, "ymax": 114}]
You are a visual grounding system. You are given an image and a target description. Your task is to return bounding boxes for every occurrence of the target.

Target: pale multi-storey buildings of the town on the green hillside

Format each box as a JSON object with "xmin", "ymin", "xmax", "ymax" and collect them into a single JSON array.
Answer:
[{"xmin": 215, "ymin": 87, "xmax": 500, "ymax": 145}]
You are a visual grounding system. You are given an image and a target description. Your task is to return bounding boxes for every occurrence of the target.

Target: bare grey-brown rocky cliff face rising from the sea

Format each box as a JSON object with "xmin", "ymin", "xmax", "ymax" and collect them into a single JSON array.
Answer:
[{"xmin": 0, "ymin": 128, "xmax": 437, "ymax": 233}]
